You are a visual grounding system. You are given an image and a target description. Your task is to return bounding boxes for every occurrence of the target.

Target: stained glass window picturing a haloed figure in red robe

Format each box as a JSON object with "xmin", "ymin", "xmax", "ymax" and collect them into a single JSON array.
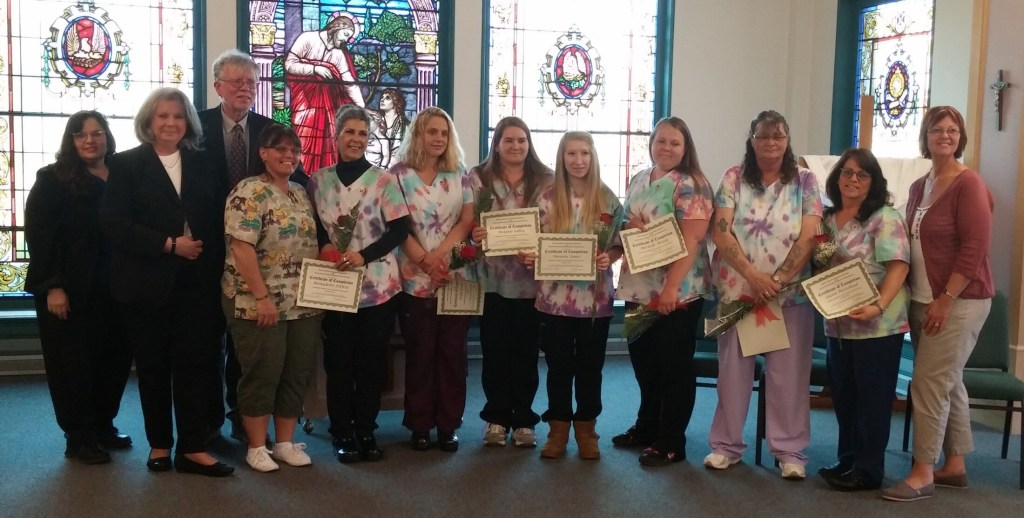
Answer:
[{"xmin": 249, "ymin": 0, "xmax": 451, "ymax": 174}]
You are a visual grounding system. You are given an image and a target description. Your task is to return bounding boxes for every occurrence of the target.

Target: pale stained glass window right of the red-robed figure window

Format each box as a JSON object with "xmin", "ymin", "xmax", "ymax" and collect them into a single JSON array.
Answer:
[{"xmin": 481, "ymin": 0, "xmax": 658, "ymax": 197}]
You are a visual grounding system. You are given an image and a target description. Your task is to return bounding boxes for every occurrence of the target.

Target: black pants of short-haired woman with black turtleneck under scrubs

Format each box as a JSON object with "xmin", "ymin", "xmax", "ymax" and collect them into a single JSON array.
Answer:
[{"xmin": 324, "ymin": 299, "xmax": 397, "ymax": 437}]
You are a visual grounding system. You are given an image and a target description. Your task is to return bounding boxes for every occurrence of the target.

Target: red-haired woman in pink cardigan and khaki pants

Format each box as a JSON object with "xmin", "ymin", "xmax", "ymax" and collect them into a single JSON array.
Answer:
[{"xmin": 883, "ymin": 106, "xmax": 995, "ymax": 502}]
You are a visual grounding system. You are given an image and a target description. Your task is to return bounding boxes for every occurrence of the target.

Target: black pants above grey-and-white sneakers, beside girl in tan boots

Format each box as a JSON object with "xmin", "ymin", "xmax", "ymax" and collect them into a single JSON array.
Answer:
[{"xmin": 480, "ymin": 293, "xmax": 541, "ymax": 428}]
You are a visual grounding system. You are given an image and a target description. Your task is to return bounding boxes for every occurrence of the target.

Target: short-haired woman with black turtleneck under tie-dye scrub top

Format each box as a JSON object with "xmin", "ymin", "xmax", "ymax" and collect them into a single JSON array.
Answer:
[{"xmin": 306, "ymin": 104, "xmax": 410, "ymax": 463}]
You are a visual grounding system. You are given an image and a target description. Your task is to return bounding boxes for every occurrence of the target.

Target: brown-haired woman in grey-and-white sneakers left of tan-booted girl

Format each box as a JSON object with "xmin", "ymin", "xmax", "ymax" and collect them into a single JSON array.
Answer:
[{"xmin": 469, "ymin": 117, "xmax": 553, "ymax": 447}]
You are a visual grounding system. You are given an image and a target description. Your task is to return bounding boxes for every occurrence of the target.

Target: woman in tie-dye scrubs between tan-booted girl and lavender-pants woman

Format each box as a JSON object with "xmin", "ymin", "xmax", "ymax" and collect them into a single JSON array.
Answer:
[{"xmin": 611, "ymin": 117, "xmax": 714, "ymax": 466}]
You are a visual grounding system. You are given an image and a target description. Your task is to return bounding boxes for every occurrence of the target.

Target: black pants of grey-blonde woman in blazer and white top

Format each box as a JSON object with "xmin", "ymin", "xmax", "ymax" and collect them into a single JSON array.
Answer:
[{"xmin": 122, "ymin": 269, "xmax": 224, "ymax": 454}]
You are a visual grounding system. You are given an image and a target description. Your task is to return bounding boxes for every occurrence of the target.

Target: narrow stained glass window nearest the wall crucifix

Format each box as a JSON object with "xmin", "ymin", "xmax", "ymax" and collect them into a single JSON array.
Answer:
[{"xmin": 854, "ymin": 0, "xmax": 934, "ymax": 158}]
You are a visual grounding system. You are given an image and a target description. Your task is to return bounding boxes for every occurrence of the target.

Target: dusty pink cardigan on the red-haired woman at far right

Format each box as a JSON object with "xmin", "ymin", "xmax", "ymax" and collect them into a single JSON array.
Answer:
[{"xmin": 906, "ymin": 169, "xmax": 995, "ymax": 299}]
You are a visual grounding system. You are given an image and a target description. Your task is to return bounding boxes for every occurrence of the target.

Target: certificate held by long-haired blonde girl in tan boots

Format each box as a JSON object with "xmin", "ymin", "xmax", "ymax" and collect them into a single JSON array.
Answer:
[{"xmin": 534, "ymin": 233, "xmax": 597, "ymax": 280}]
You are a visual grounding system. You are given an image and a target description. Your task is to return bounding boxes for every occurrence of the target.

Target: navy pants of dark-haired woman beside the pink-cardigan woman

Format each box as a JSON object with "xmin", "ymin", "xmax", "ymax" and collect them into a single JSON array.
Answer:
[{"xmin": 826, "ymin": 333, "xmax": 903, "ymax": 482}]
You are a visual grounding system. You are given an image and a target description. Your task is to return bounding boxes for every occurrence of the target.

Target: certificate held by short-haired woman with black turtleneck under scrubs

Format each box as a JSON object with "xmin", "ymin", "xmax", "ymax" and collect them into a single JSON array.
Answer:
[{"xmin": 296, "ymin": 259, "xmax": 366, "ymax": 313}]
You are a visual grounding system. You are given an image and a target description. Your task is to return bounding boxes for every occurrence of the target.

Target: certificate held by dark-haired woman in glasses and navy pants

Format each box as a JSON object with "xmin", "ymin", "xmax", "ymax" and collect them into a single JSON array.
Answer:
[{"xmin": 801, "ymin": 258, "xmax": 879, "ymax": 318}]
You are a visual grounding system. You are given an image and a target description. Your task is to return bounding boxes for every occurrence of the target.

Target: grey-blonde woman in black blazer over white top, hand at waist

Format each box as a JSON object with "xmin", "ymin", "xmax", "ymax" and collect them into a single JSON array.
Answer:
[{"xmin": 100, "ymin": 88, "xmax": 234, "ymax": 476}]
